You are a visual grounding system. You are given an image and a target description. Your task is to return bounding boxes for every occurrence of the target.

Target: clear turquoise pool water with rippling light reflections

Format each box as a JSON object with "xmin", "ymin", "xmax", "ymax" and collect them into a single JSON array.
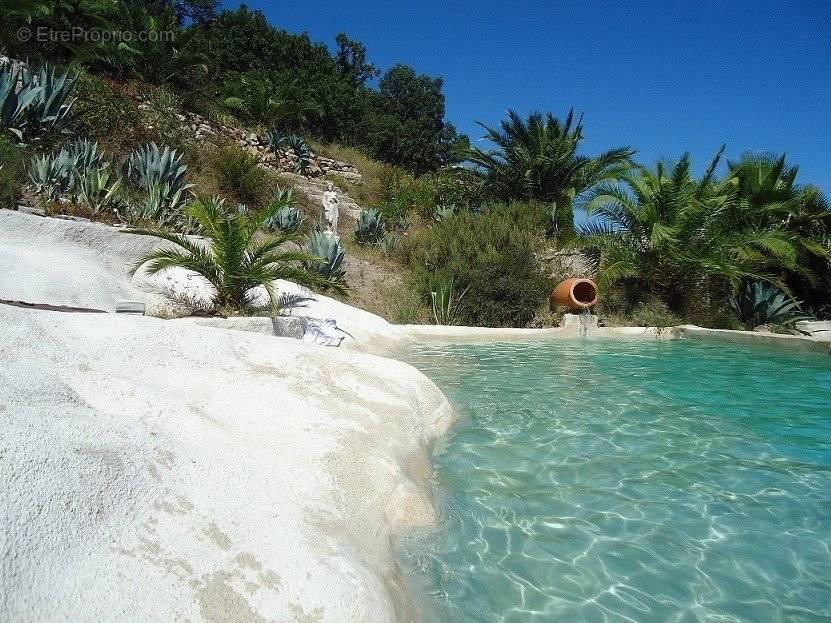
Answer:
[{"xmin": 398, "ymin": 340, "xmax": 831, "ymax": 623}]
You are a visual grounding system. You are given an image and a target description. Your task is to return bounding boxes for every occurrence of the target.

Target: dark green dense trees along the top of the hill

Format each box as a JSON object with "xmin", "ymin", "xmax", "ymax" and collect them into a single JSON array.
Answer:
[{"xmin": 0, "ymin": 0, "xmax": 467, "ymax": 173}]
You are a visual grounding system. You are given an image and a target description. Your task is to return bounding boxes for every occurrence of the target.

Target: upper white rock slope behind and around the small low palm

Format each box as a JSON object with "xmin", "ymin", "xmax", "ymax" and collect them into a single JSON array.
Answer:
[{"xmin": 0, "ymin": 210, "xmax": 403, "ymax": 347}]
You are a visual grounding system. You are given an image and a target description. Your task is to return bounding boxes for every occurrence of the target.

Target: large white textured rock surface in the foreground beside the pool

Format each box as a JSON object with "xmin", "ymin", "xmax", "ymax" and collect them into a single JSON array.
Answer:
[{"xmin": 0, "ymin": 304, "xmax": 451, "ymax": 622}]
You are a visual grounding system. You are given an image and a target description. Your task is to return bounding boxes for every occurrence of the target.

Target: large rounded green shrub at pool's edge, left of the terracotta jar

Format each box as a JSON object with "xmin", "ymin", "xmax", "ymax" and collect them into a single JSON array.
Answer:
[{"xmin": 404, "ymin": 204, "xmax": 553, "ymax": 327}]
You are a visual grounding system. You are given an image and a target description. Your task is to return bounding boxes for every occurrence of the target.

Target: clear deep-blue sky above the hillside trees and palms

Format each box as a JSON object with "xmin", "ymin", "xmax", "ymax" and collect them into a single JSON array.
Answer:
[{"xmin": 225, "ymin": 0, "xmax": 831, "ymax": 194}]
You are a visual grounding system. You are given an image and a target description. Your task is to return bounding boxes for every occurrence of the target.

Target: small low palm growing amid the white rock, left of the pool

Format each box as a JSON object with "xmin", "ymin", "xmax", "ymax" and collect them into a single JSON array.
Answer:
[{"xmin": 129, "ymin": 198, "xmax": 345, "ymax": 312}]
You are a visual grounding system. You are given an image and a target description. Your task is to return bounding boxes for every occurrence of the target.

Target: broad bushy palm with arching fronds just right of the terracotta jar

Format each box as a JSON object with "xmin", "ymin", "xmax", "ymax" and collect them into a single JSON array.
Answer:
[{"xmin": 576, "ymin": 147, "xmax": 796, "ymax": 312}]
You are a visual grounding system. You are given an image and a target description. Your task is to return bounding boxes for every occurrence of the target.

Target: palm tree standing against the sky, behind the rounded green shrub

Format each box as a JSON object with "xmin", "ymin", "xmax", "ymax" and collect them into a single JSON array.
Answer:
[{"xmin": 469, "ymin": 110, "xmax": 635, "ymax": 236}]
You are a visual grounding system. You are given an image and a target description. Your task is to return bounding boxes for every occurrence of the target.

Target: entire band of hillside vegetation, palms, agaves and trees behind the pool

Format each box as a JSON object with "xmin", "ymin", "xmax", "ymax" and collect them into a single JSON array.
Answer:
[{"xmin": 0, "ymin": 0, "xmax": 831, "ymax": 328}]
